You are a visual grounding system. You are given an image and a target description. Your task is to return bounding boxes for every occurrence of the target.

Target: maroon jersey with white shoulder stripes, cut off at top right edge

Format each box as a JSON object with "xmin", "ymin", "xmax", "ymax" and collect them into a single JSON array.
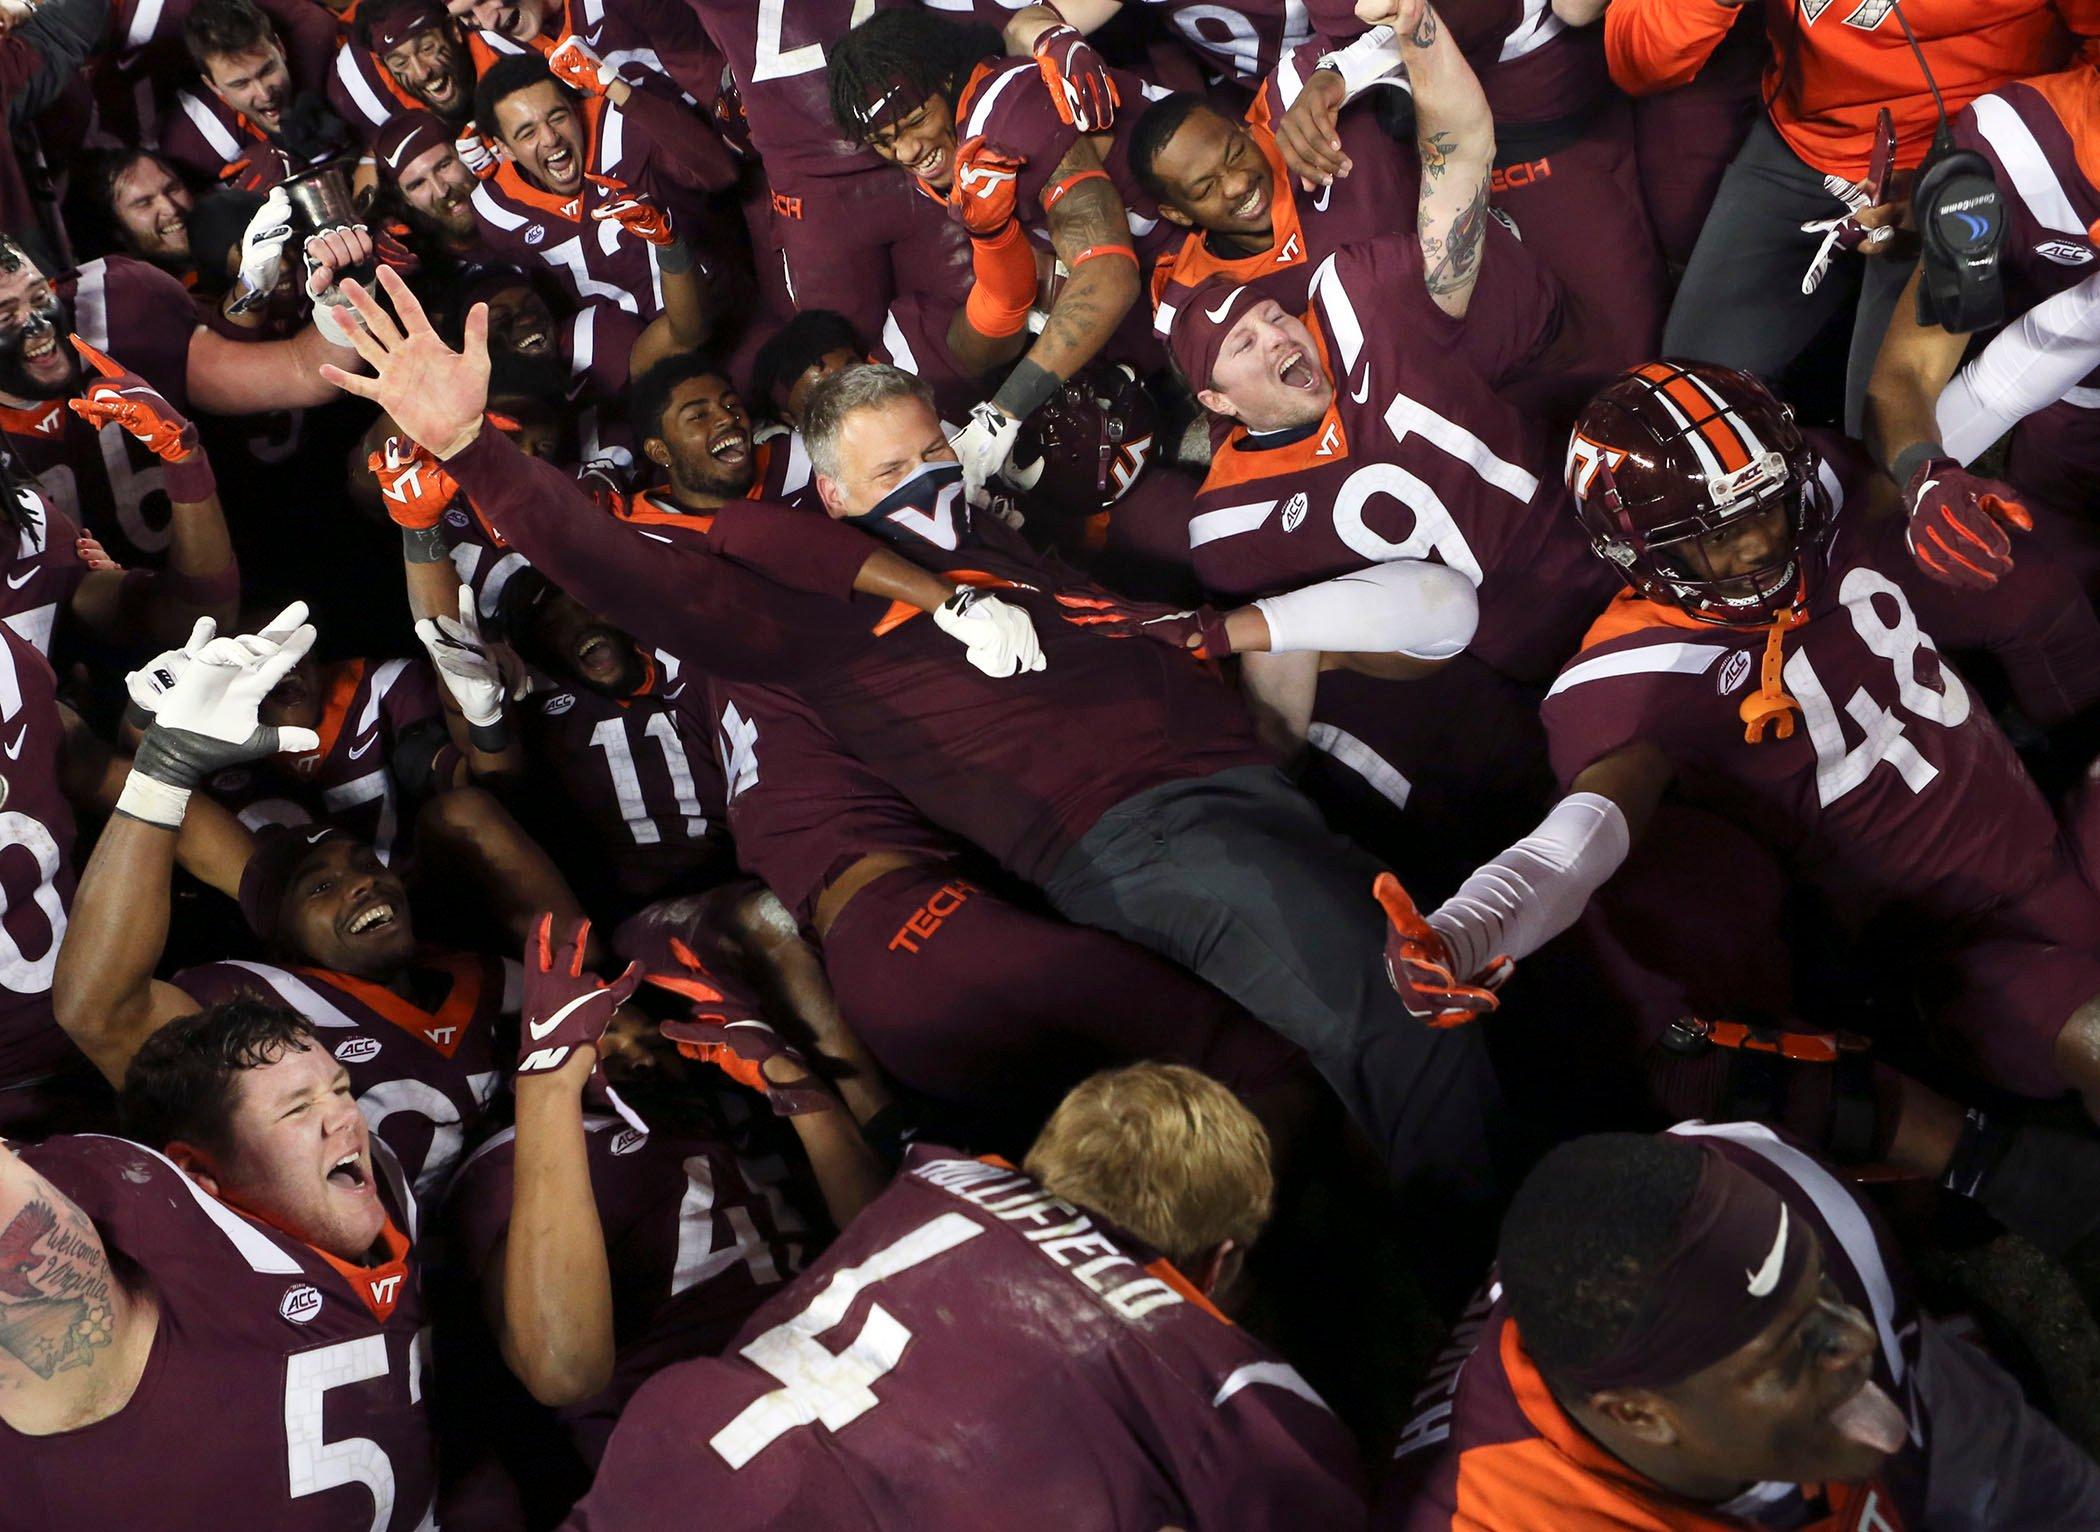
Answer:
[{"xmin": 1955, "ymin": 67, "xmax": 2100, "ymax": 390}]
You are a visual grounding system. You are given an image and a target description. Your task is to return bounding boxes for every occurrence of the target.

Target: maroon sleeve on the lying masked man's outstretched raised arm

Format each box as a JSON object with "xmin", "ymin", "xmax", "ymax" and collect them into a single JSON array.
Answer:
[{"xmin": 445, "ymin": 430, "xmax": 867, "ymax": 680}]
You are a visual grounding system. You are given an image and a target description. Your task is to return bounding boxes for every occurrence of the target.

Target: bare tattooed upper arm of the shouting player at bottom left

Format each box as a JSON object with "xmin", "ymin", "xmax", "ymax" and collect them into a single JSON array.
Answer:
[{"xmin": 0, "ymin": 1142, "xmax": 155, "ymax": 1435}]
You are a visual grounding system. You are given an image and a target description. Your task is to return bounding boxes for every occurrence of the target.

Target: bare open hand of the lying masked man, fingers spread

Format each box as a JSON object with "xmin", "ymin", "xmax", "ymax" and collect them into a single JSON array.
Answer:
[{"xmin": 321, "ymin": 267, "xmax": 489, "ymax": 460}]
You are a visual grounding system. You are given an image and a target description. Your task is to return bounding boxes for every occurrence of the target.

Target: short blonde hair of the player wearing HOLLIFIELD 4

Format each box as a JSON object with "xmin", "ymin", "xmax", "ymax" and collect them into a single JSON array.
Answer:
[{"xmin": 1023, "ymin": 1064, "xmax": 1275, "ymax": 1268}]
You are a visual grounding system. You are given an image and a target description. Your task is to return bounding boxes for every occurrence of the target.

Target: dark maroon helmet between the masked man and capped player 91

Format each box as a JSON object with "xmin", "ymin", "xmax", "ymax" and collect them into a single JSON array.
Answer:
[{"xmin": 1006, "ymin": 361, "xmax": 1159, "ymax": 516}]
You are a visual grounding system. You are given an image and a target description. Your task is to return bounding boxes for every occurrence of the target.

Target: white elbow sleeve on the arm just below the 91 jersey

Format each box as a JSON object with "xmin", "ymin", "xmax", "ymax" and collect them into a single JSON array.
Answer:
[{"xmin": 1254, "ymin": 558, "xmax": 1481, "ymax": 659}]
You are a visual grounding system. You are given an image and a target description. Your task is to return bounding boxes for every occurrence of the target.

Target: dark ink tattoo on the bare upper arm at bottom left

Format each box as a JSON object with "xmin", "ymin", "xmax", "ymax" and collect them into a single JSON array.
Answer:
[{"xmin": 0, "ymin": 1196, "xmax": 116, "ymax": 1381}]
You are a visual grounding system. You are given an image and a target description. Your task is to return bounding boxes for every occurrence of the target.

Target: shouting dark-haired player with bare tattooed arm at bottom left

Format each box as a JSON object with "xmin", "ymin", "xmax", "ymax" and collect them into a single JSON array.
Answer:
[{"xmin": 0, "ymin": 1003, "xmax": 437, "ymax": 1532}]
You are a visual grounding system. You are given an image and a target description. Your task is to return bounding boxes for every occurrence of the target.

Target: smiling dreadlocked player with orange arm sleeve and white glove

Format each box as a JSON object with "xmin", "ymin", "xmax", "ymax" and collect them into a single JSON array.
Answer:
[{"xmin": 832, "ymin": 10, "xmax": 1166, "ymax": 501}]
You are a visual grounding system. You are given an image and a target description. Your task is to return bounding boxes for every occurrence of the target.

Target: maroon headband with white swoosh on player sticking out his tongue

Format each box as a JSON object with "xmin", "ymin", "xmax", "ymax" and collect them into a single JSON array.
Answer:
[{"xmin": 1565, "ymin": 1144, "xmax": 1810, "ymax": 1393}]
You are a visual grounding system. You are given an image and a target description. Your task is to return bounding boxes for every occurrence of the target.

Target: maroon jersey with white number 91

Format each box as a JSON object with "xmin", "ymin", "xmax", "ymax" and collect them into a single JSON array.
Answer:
[{"xmin": 1189, "ymin": 235, "xmax": 1617, "ymax": 680}]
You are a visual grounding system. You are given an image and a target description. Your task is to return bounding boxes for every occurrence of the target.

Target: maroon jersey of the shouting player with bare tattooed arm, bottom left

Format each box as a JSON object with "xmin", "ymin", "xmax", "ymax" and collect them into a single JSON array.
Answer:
[{"xmin": 0, "ymin": 1135, "xmax": 437, "ymax": 1532}]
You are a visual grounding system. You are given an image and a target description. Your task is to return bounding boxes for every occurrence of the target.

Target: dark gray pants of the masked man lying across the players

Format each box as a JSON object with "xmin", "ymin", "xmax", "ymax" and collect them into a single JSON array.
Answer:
[{"xmin": 1044, "ymin": 766, "xmax": 1502, "ymax": 1200}]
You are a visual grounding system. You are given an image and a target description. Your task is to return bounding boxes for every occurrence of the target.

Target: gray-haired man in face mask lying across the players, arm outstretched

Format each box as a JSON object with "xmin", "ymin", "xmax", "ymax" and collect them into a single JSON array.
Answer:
[{"xmin": 328, "ymin": 271, "xmax": 1497, "ymax": 1190}]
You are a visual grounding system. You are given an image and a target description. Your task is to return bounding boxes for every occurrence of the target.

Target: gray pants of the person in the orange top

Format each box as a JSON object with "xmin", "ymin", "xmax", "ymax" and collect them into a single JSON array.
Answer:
[{"xmin": 1663, "ymin": 118, "xmax": 1917, "ymax": 437}]
